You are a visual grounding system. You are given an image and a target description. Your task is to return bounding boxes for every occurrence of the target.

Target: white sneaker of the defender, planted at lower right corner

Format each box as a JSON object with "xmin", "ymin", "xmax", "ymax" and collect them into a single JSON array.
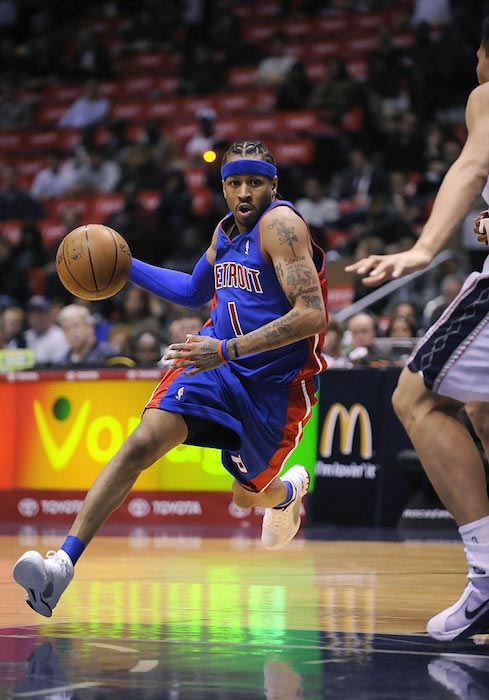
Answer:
[{"xmin": 426, "ymin": 576, "xmax": 489, "ymax": 641}]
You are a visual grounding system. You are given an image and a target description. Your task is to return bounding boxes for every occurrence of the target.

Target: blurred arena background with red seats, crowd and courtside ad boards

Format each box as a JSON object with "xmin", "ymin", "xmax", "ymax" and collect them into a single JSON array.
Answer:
[{"xmin": 0, "ymin": 0, "xmax": 489, "ymax": 527}]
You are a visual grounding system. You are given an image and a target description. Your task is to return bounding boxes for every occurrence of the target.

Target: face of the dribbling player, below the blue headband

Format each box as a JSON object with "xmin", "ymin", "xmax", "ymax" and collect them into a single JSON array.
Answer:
[{"xmin": 223, "ymin": 168, "xmax": 277, "ymax": 232}]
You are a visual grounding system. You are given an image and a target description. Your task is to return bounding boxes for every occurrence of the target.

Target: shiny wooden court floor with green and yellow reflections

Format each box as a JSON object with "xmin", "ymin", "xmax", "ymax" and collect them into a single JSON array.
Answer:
[{"xmin": 0, "ymin": 529, "xmax": 489, "ymax": 700}]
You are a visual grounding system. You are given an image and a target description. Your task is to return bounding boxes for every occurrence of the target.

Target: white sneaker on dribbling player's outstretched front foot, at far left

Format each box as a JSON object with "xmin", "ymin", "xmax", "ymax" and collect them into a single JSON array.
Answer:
[{"xmin": 13, "ymin": 549, "xmax": 73, "ymax": 617}]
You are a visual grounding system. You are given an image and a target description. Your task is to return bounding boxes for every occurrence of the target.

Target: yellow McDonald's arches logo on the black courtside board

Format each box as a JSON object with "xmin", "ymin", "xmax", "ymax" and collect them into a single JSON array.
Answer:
[{"xmin": 319, "ymin": 403, "xmax": 372, "ymax": 459}]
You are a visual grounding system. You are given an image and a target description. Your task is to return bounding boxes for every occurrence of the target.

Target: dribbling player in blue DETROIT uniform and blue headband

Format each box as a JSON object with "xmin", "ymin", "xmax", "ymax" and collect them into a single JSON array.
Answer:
[{"xmin": 13, "ymin": 141, "xmax": 327, "ymax": 617}]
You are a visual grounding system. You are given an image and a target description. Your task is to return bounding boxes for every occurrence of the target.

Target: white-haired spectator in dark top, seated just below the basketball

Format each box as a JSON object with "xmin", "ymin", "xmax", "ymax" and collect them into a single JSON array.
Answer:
[{"xmin": 57, "ymin": 304, "xmax": 115, "ymax": 367}]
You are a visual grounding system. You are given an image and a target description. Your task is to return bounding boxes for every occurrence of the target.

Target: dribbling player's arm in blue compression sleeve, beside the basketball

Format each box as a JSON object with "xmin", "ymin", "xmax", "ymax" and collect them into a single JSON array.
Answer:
[{"xmin": 129, "ymin": 228, "xmax": 217, "ymax": 309}]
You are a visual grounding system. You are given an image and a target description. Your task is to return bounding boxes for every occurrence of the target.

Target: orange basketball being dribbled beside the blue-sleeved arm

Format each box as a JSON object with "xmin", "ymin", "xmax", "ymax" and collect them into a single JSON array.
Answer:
[{"xmin": 56, "ymin": 224, "xmax": 132, "ymax": 301}]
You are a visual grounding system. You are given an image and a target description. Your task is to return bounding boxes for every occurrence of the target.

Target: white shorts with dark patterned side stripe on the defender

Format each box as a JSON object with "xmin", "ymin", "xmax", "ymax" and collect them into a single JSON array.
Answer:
[{"xmin": 407, "ymin": 256, "xmax": 489, "ymax": 403}]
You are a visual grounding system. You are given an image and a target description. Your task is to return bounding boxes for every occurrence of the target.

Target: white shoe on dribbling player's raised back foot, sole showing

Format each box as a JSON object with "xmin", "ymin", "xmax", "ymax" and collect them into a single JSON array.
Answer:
[{"xmin": 261, "ymin": 464, "xmax": 309, "ymax": 549}]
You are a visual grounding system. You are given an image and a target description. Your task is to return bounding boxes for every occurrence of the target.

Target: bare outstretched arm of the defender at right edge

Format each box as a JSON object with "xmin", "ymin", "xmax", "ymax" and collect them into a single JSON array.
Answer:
[{"xmin": 346, "ymin": 83, "xmax": 489, "ymax": 287}]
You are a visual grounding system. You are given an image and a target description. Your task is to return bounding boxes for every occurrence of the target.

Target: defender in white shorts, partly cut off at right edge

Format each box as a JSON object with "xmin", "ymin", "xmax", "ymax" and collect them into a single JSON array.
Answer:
[{"xmin": 347, "ymin": 18, "xmax": 489, "ymax": 640}]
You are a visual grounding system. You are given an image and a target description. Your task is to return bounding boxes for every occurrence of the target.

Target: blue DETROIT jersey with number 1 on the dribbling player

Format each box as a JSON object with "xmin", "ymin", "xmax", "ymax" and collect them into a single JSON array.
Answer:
[{"xmin": 201, "ymin": 200, "xmax": 327, "ymax": 383}]
